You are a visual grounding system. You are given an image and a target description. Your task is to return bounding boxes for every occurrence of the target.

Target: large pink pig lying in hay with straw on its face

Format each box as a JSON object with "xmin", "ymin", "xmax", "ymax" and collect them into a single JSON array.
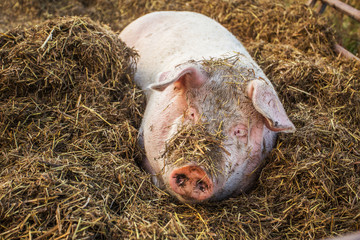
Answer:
[{"xmin": 119, "ymin": 11, "xmax": 295, "ymax": 203}]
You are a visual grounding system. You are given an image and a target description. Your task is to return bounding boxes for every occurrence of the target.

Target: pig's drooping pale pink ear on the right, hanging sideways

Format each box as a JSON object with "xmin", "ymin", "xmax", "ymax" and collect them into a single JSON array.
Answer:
[{"xmin": 247, "ymin": 80, "xmax": 295, "ymax": 132}]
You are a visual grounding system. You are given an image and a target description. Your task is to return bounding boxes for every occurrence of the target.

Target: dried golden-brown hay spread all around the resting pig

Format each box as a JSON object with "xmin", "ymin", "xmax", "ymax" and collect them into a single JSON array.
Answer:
[{"xmin": 0, "ymin": 0, "xmax": 360, "ymax": 239}]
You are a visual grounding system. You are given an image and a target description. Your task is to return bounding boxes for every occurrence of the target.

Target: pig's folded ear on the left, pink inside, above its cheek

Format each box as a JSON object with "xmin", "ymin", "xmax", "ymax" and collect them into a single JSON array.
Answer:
[{"xmin": 149, "ymin": 66, "xmax": 207, "ymax": 91}]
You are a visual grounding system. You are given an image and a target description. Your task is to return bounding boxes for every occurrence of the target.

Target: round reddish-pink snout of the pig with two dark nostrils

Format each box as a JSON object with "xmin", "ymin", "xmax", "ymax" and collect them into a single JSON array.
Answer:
[{"xmin": 169, "ymin": 166, "xmax": 213, "ymax": 201}]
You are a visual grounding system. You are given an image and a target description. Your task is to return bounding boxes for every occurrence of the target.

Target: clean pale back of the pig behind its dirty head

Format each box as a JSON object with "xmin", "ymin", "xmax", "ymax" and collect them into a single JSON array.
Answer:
[{"xmin": 120, "ymin": 12, "xmax": 266, "ymax": 89}]
